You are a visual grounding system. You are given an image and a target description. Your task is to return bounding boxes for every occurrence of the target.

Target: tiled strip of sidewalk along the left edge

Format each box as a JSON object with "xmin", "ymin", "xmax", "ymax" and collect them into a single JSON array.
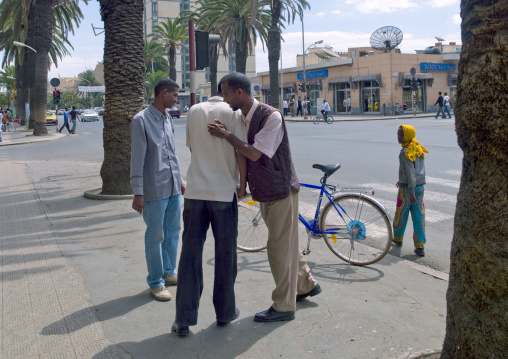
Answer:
[{"xmin": 0, "ymin": 162, "xmax": 114, "ymax": 359}]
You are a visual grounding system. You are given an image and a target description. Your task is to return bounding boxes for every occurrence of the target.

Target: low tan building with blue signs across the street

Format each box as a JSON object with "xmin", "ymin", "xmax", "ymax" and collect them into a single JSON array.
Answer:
[{"xmin": 258, "ymin": 49, "xmax": 460, "ymax": 115}]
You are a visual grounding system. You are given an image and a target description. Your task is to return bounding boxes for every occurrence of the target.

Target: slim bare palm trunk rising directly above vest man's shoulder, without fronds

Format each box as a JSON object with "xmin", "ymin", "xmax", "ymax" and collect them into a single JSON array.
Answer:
[{"xmin": 267, "ymin": 0, "xmax": 282, "ymax": 112}]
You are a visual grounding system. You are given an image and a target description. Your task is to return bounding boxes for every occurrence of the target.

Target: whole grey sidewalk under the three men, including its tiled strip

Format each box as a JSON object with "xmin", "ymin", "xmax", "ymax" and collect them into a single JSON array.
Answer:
[{"xmin": 0, "ymin": 161, "xmax": 448, "ymax": 359}]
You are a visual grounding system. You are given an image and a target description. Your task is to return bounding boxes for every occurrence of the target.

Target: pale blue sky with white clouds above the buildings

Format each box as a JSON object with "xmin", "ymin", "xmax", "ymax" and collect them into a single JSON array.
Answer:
[{"xmin": 30, "ymin": 0, "xmax": 462, "ymax": 78}]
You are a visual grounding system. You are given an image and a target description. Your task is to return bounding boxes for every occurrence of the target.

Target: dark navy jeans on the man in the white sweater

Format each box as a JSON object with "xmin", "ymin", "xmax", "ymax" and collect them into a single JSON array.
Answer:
[{"xmin": 175, "ymin": 197, "xmax": 238, "ymax": 326}]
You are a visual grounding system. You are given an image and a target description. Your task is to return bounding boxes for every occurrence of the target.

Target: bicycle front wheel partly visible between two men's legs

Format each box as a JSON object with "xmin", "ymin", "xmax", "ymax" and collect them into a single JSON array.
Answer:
[{"xmin": 236, "ymin": 195, "xmax": 268, "ymax": 252}]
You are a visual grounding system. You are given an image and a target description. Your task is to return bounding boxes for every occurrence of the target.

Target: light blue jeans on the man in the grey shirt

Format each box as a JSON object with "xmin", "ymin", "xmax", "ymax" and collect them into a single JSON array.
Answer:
[{"xmin": 143, "ymin": 194, "xmax": 182, "ymax": 288}]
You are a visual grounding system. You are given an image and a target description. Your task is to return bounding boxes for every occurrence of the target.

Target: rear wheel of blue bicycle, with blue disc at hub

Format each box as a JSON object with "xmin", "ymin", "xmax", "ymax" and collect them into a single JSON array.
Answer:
[{"xmin": 320, "ymin": 194, "xmax": 392, "ymax": 265}]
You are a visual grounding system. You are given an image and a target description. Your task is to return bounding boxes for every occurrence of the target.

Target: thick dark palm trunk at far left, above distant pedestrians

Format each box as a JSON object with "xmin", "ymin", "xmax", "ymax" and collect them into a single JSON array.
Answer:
[{"xmin": 30, "ymin": 0, "xmax": 53, "ymax": 136}]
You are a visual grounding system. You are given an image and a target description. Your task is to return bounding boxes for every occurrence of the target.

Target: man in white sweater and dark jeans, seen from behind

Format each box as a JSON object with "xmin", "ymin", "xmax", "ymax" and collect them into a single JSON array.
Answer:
[{"xmin": 172, "ymin": 83, "xmax": 247, "ymax": 336}]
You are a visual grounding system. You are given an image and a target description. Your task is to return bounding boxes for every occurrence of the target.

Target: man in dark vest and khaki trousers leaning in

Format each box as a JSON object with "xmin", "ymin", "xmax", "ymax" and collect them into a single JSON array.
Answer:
[{"xmin": 208, "ymin": 73, "xmax": 321, "ymax": 322}]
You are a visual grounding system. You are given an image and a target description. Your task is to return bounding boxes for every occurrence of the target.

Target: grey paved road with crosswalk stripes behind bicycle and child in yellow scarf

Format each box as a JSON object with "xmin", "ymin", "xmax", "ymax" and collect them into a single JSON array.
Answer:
[{"xmin": 0, "ymin": 117, "xmax": 462, "ymax": 273}]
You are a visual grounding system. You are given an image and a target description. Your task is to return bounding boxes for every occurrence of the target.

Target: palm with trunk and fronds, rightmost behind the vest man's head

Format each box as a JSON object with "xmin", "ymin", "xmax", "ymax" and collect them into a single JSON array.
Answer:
[{"xmin": 261, "ymin": 0, "xmax": 310, "ymax": 108}]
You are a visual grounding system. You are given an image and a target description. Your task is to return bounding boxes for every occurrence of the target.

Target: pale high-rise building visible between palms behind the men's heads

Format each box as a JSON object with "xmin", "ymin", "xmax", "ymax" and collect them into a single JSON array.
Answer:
[{"xmin": 144, "ymin": 0, "xmax": 256, "ymax": 108}]
